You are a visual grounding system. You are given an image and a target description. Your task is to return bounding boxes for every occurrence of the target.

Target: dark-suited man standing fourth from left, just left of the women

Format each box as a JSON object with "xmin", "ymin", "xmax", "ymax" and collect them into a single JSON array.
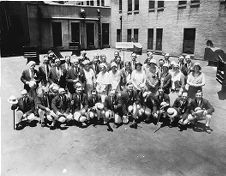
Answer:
[{"xmin": 66, "ymin": 58, "xmax": 86, "ymax": 94}]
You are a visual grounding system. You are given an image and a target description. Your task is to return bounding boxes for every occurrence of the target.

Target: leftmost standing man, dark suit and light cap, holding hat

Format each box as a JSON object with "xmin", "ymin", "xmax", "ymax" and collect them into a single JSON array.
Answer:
[{"xmin": 20, "ymin": 61, "xmax": 41, "ymax": 99}]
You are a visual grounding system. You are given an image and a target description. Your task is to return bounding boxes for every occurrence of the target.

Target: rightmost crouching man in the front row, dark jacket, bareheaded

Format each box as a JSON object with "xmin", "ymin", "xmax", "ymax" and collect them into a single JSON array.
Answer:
[{"xmin": 183, "ymin": 90, "xmax": 214, "ymax": 132}]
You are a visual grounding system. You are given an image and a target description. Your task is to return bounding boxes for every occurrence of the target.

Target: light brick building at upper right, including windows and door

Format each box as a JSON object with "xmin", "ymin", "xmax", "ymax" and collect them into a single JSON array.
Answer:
[{"xmin": 111, "ymin": 0, "xmax": 226, "ymax": 58}]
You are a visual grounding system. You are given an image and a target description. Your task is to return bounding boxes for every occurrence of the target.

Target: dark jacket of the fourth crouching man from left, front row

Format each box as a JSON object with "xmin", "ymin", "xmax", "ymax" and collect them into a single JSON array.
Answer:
[{"xmin": 71, "ymin": 93, "xmax": 88, "ymax": 113}]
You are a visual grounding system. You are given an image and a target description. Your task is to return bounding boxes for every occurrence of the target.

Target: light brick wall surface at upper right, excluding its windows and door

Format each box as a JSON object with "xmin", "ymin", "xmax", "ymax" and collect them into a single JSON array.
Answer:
[{"xmin": 111, "ymin": 0, "xmax": 226, "ymax": 59}]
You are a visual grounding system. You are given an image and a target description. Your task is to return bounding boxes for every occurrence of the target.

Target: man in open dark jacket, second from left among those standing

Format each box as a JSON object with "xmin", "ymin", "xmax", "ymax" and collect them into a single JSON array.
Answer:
[{"xmin": 39, "ymin": 56, "xmax": 51, "ymax": 86}]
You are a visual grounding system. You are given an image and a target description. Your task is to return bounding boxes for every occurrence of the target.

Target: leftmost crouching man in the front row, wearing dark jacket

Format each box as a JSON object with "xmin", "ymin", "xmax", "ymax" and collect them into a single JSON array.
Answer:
[{"xmin": 11, "ymin": 89, "xmax": 38, "ymax": 130}]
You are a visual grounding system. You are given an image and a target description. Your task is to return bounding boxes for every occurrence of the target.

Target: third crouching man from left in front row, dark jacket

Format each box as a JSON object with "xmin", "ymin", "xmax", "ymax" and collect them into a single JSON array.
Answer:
[{"xmin": 51, "ymin": 88, "xmax": 73, "ymax": 129}]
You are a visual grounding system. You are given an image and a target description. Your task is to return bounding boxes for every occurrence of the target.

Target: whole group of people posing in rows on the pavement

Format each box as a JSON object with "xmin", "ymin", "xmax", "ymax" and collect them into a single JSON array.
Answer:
[{"xmin": 9, "ymin": 51, "xmax": 214, "ymax": 131}]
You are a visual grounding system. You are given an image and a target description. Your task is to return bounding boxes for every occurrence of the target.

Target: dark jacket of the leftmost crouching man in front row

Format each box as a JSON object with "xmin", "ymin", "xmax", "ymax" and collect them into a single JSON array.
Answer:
[{"xmin": 11, "ymin": 96, "xmax": 35, "ymax": 114}]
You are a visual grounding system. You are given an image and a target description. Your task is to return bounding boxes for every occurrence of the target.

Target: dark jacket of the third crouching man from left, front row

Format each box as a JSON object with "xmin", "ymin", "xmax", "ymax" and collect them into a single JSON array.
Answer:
[{"xmin": 51, "ymin": 95, "xmax": 70, "ymax": 113}]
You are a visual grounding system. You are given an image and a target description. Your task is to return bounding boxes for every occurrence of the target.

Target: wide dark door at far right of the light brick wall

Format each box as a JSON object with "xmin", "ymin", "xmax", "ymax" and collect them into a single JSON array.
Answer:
[{"xmin": 183, "ymin": 28, "xmax": 195, "ymax": 54}]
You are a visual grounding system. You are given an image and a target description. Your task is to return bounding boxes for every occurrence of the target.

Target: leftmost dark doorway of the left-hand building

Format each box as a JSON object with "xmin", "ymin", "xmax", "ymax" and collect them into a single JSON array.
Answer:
[{"xmin": 52, "ymin": 22, "xmax": 62, "ymax": 47}]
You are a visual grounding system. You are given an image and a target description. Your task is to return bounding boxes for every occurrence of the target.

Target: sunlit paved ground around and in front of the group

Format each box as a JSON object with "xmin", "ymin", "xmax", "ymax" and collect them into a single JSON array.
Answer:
[{"xmin": 1, "ymin": 49, "xmax": 226, "ymax": 176}]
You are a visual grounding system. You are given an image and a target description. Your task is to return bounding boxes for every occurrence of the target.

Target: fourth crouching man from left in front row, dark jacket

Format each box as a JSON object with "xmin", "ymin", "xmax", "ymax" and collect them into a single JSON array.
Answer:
[{"xmin": 71, "ymin": 82, "xmax": 88, "ymax": 126}]
